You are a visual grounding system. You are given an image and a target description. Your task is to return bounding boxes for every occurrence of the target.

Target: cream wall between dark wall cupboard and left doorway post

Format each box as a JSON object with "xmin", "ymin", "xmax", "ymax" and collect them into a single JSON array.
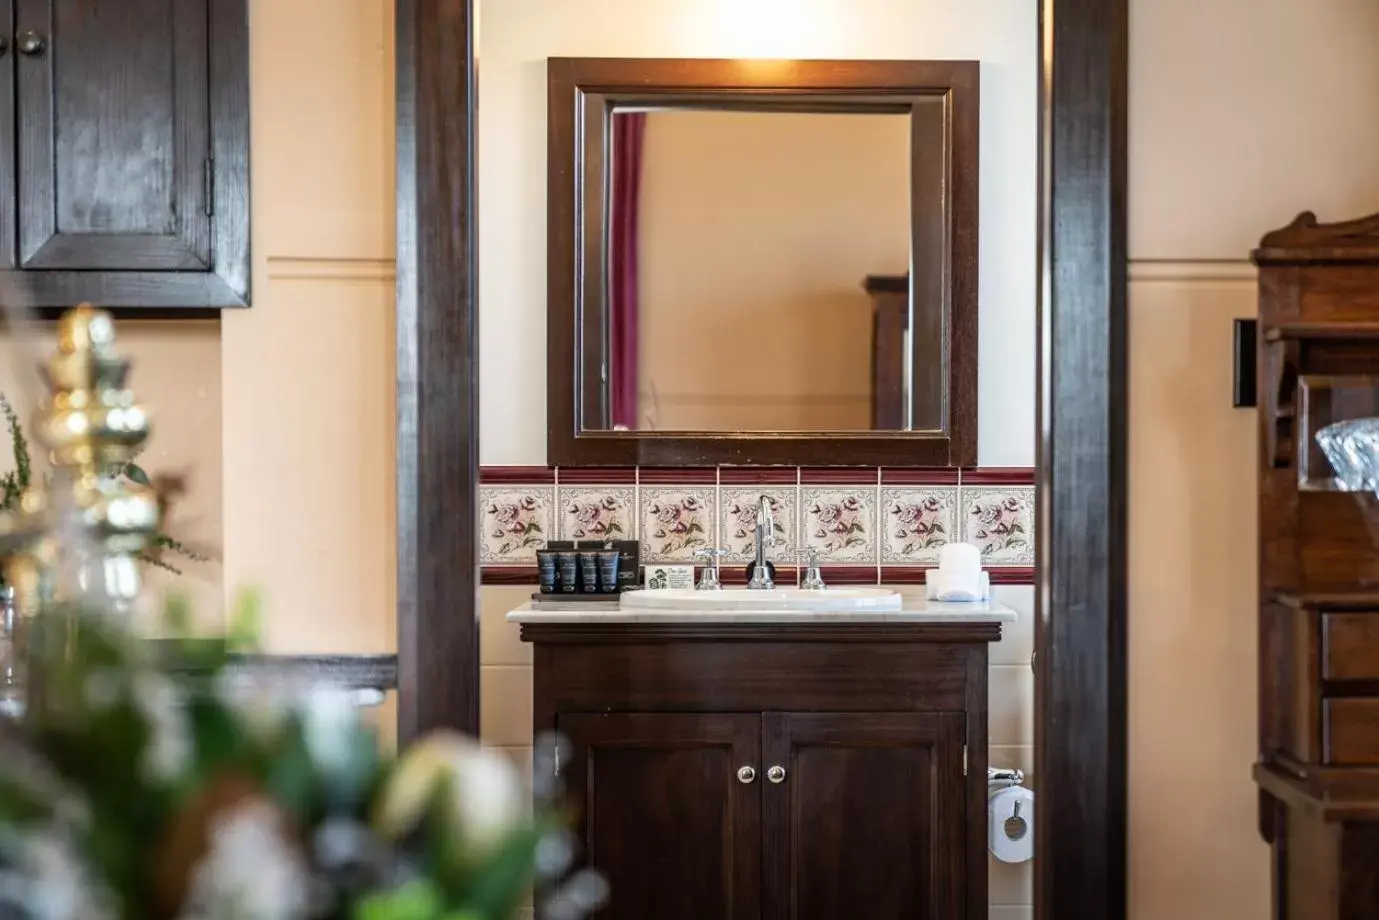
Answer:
[{"xmin": 221, "ymin": 0, "xmax": 396, "ymax": 652}]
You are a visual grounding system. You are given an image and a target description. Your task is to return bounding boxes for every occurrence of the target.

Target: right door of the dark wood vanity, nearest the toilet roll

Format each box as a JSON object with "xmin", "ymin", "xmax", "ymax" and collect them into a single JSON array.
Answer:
[{"xmin": 761, "ymin": 713, "xmax": 965, "ymax": 920}]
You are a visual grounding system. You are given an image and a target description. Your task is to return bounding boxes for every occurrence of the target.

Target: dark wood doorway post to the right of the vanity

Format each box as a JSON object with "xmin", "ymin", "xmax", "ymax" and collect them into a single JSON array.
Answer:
[{"xmin": 1034, "ymin": 0, "xmax": 1129, "ymax": 920}]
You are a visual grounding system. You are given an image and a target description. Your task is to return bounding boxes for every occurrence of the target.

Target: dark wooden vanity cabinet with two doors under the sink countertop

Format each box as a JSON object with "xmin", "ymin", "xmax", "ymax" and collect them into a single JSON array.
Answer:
[{"xmin": 521, "ymin": 622, "xmax": 1000, "ymax": 920}]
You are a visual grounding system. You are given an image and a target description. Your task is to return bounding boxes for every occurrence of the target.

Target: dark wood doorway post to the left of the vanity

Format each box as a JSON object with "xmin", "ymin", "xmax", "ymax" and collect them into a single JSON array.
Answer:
[{"xmin": 394, "ymin": 0, "xmax": 479, "ymax": 743}]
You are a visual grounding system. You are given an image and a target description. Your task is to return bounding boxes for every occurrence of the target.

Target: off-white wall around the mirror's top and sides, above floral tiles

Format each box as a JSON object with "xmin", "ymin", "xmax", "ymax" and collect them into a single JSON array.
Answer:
[{"xmin": 479, "ymin": 0, "xmax": 1038, "ymax": 466}]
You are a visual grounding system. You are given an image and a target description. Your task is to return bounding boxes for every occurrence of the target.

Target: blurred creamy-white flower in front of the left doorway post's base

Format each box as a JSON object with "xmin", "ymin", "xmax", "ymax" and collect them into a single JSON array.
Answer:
[{"xmin": 375, "ymin": 732, "xmax": 523, "ymax": 852}]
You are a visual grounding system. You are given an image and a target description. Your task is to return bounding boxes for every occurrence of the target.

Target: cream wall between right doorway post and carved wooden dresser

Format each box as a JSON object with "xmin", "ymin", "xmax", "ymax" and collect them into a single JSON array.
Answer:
[{"xmin": 1129, "ymin": 0, "xmax": 1379, "ymax": 920}]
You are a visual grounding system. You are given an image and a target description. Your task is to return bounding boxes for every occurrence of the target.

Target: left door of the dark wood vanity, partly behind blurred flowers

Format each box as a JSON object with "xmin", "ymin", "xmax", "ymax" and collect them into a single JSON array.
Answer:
[{"xmin": 558, "ymin": 713, "xmax": 765, "ymax": 920}]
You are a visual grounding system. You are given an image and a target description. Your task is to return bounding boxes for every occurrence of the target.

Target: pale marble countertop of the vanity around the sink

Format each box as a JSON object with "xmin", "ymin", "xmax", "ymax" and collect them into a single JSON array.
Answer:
[{"xmin": 507, "ymin": 597, "xmax": 1016, "ymax": 626}]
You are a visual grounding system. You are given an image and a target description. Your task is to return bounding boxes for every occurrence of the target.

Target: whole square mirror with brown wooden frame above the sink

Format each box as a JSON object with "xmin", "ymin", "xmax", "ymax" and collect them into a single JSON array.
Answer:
[{"xmin": 547, "ymin": 58, "xmax": 979, "ymax": 466}]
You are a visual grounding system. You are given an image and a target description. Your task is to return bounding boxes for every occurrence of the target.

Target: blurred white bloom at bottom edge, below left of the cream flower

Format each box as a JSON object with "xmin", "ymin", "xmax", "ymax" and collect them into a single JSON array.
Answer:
[{"xmin": 182, "ymin": 801, "xmax": 310, "ymax": 920}]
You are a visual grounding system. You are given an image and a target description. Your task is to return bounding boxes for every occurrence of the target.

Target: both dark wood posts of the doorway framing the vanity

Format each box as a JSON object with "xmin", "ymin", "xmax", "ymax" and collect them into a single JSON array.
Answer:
[{"xmin": 396, "ymin": 0, "xmax": 1128, "ymax": 920}]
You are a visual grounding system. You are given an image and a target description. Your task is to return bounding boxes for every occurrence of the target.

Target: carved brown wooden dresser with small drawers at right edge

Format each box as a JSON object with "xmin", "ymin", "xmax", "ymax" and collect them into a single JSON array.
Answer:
[{"xmin": 1255, "ymin": 214, "xmax": 1379, "ymax": 920}]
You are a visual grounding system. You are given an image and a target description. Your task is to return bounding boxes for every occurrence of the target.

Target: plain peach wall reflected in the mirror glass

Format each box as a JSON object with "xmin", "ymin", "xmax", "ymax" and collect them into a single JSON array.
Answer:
[{"xmin": 637, "ymin": 110, "xmax": 912, "ymax": 430}]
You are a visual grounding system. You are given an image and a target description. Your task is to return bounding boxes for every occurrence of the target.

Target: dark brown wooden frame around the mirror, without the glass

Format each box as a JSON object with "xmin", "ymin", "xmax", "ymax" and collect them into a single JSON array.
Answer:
[{"xmin": 546, "ymin": 58, "xmax": 980, "ymax": 468}]
